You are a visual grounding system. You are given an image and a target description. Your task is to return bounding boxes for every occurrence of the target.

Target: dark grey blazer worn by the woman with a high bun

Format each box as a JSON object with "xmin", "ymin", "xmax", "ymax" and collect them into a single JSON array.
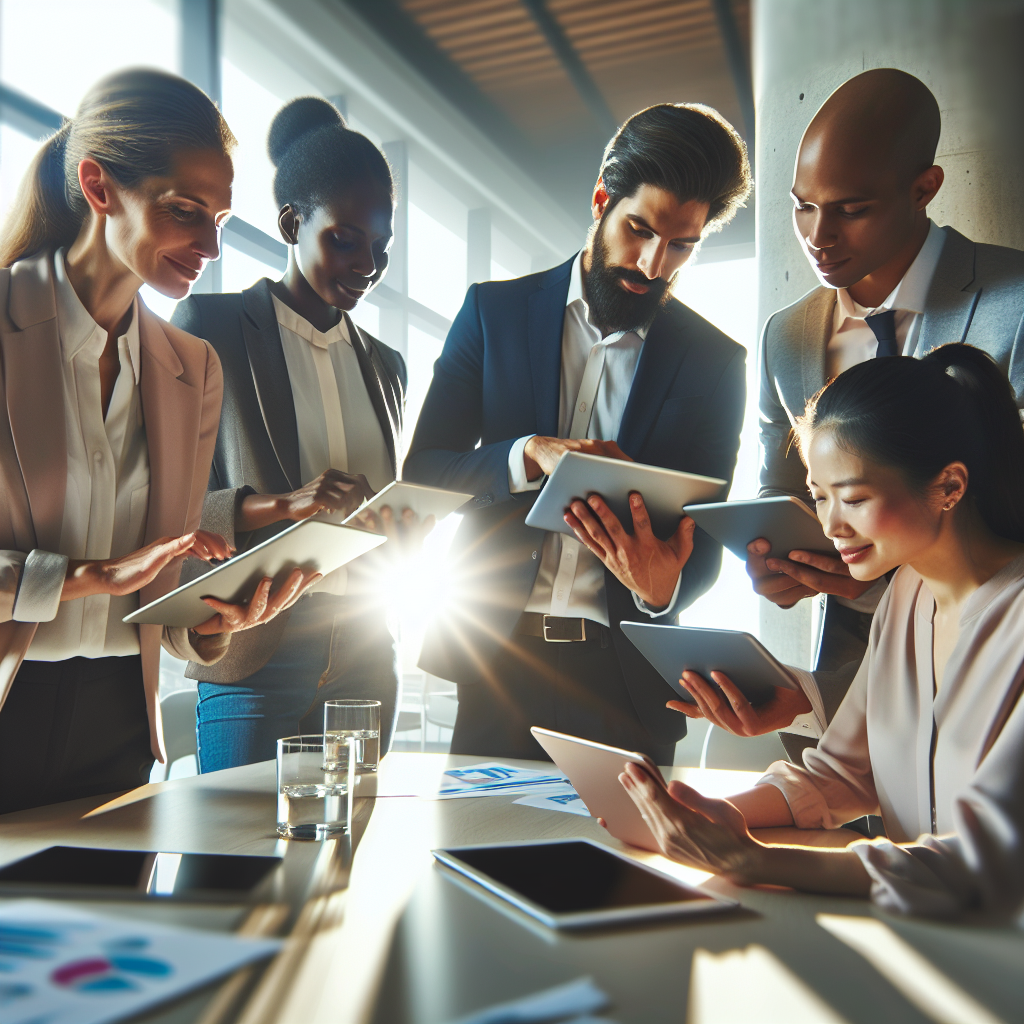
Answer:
[{"xmin": 172, "ymin": 278, "xmax": 408, "ymax": 683}]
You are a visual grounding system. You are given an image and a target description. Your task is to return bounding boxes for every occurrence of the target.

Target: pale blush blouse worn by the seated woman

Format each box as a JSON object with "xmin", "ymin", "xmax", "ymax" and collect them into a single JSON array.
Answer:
[{"xmin": 759, "ymin": 556, "xmax": 1024, "ymax": 915}]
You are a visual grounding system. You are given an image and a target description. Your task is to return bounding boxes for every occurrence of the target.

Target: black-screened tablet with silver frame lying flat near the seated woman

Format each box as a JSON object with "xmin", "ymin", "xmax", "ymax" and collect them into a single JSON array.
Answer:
[{"xmin": 431, "ymin": 839, "xmax": 739, "ymax": 929}]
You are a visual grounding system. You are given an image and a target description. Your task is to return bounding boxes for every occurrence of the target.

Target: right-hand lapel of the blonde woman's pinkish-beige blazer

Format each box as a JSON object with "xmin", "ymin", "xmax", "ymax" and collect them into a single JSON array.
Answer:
[{"xmin": 137, "ymin": 302, "xmax": 203, "ymax": 604}]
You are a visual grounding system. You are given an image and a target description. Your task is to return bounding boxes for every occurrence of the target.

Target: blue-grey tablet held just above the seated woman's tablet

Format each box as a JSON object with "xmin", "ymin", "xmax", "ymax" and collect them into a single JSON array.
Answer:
[{"xmin": 618, "ymin": 623, "xmax": 800, "ymax": 708}]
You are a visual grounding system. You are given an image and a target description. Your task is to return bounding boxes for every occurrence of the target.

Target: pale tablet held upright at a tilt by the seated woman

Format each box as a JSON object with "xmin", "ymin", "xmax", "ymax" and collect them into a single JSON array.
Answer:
[{"xmin": 529, "ymin": 725, "xmax": 664, "ymax": 852}]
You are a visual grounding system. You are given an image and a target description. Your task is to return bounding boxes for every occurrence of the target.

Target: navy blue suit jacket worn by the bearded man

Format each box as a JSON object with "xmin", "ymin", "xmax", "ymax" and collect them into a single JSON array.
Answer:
[{"xmin": 403, "ymin": 260, "xmax": 746, "ymax": 741}]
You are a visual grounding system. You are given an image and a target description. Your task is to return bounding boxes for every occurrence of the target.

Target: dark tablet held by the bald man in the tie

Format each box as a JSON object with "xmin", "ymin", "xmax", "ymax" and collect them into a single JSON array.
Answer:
[{"xmin": 686, "ymin": 497, "xmax": 836, "ymax": 561}]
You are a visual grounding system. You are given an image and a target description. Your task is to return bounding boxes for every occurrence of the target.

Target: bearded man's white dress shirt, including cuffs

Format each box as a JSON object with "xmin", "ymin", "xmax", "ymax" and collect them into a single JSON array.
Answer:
[{"xmin": 509, "ymin": 252, "xmax": 682, "ymax": 626}]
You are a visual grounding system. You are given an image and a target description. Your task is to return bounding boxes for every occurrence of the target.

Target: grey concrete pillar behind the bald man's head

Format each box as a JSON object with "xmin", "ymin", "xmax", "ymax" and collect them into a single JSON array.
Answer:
[{"xmin": 753, "ymin": 0, "xmax": 1024, "ymax": 665}]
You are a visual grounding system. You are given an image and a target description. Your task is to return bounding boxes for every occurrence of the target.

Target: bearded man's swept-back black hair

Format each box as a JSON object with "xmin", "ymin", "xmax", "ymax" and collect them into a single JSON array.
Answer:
[{"xmin": 601, "ymin": 103, "xmax": 753, "ymax": 234}]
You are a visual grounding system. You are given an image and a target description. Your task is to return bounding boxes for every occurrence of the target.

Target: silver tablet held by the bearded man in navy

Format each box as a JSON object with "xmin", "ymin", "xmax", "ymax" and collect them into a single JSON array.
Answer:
[{"xmin": 526, "ymin": 452, "xmax": 726, "ymax": 539}]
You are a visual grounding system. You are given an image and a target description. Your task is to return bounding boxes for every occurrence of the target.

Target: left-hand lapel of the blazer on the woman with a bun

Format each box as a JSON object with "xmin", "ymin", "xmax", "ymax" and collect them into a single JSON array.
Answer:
[{"xmin": 242, "ymin": 278, "xmax": 305, "ymax": 488}]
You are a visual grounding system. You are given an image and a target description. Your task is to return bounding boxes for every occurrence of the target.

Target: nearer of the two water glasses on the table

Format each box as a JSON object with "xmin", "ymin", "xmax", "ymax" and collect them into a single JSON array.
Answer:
[{"xmin": 278, "ymin": 735, "xmax": 354, "ymax": 839}]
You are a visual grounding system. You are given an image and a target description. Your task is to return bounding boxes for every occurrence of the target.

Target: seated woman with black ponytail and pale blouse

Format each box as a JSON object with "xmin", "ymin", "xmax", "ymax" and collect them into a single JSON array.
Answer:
[{"xmin": 621, "ymin": 345, "xmax": 1024, "ymax": 916}]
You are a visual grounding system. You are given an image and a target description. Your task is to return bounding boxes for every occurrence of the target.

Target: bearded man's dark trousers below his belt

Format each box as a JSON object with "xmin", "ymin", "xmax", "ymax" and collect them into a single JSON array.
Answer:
[{"xmin": 452, "ymin": 630, "xmax": 675, "ymax": 765}]
